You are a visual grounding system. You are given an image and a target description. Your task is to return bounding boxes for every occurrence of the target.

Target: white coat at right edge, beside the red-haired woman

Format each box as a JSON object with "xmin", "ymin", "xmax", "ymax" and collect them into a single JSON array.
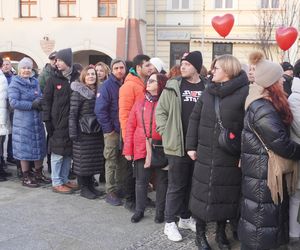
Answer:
[{"xmin": 289, "ymin": 77, "xmax": 300, "ymax": 189}]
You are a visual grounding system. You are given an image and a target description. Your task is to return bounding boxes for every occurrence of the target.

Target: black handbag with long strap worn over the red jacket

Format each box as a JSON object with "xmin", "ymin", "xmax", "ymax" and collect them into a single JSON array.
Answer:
[{"xmin": 142, "ymin": 99, "xmax": 168, "ymax": 168}]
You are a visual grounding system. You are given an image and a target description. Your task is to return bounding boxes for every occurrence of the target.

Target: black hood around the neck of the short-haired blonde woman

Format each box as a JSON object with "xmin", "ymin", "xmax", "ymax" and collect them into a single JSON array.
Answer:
[{"xmin": 207, "ymin": 70, "xmax": 248, "ymax": 98}]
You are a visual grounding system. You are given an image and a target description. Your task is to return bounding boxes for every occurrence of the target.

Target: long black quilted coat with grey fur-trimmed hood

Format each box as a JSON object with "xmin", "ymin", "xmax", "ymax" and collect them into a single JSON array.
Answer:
[{"xmin": 69, "ymin": 82, "xmax": 103, "ymax": 176}]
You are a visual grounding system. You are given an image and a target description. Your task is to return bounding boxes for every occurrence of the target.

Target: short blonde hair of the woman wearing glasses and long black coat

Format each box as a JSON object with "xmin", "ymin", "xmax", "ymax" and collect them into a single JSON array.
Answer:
[{"xmin": 216, "ymin": 55, "xmax": 242, "ymax": 79}]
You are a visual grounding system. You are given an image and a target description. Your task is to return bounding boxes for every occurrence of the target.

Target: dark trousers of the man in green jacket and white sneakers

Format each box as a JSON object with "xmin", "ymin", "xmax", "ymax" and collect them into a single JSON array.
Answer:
[{"xmin": 165, "ymin": 155, "xmax": 194, "ymax": 223}]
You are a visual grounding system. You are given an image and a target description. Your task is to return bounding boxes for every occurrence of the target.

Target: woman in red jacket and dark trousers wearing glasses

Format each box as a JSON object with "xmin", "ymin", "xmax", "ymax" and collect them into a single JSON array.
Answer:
[{"xmin": 123, "ymin": 73, "xmax": 168, "ymax": 223}]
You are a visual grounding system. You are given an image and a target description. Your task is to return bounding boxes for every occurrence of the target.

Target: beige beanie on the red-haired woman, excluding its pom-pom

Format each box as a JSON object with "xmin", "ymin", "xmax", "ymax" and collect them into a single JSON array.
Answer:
[{"xmin": 254, "ymin": 59, "xmax": 284, "ymax": 88}]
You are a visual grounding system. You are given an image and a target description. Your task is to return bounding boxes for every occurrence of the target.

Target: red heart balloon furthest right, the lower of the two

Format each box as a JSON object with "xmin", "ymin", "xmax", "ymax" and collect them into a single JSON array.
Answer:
[{"xmin": 276, "ymin": 27, "xmax": 298, "ymax": 51}]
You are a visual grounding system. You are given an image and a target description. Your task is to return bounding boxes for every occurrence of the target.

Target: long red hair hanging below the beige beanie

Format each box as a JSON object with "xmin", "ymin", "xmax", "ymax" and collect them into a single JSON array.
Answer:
[{"xmin": 266, "ymin": 82, "xmax": 293, "ymax": 125}]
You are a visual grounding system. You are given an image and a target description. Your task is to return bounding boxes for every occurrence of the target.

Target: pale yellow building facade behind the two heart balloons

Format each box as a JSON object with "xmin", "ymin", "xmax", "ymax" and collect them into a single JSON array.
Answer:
[{"xmin": 146, "ymin": 0, "xmax": 299, "ymax": 70}]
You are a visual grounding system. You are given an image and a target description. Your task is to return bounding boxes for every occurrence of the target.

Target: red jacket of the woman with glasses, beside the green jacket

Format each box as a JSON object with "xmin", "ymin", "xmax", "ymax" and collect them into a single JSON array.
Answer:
[{"xmin": 123, "ymin": 96, "xmax": 161, "ymax": 160}]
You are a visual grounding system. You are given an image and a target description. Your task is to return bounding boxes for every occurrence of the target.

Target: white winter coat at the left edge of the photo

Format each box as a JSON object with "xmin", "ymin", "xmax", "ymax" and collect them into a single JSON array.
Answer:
[{"xmin": 0, "ymin": 70, "xmax": 10, "ymax": 136}]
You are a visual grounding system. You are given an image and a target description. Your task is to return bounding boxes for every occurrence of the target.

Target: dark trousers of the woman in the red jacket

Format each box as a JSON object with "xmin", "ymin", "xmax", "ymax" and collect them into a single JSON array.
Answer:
[{"xmin": 135, "ymin": 159, "xmax": 168, "ymax": 213}]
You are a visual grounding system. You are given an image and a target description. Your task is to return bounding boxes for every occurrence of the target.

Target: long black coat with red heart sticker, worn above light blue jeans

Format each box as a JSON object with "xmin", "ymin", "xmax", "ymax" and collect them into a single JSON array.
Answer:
[{"xmin": 42, "ymin": 69, "xmax": 79, "ymax": 156}]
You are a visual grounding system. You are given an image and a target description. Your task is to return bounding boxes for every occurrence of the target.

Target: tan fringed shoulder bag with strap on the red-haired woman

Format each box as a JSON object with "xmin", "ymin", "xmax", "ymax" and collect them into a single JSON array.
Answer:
[{"xmin": 248, "ymin": 123, "xmax": 298, "ymax": 205}]
